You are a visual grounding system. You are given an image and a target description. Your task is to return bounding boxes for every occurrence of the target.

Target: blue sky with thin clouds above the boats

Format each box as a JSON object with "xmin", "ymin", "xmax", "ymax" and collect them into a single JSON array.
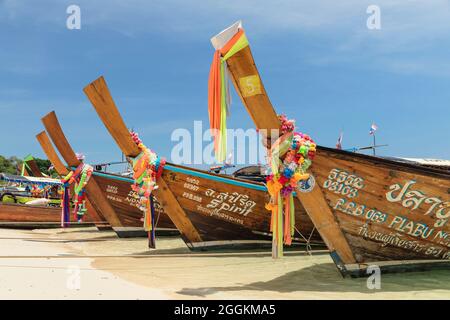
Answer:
[{"xmin": 0, "ymin": 0, "xmax": 450, "ymax": 162}]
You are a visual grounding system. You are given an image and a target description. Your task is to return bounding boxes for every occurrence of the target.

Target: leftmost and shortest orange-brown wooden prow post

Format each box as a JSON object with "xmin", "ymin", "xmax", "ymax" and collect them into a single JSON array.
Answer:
[{"xmin": 36, "ymin": 131, "xmax": 106, "ymax": 228}]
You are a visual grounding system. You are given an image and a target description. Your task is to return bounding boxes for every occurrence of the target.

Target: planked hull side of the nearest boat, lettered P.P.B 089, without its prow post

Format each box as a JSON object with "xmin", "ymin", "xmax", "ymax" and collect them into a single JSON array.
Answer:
[{"xmin": 311, "ymin": 147, "xmax": 450, "ymax": 265}]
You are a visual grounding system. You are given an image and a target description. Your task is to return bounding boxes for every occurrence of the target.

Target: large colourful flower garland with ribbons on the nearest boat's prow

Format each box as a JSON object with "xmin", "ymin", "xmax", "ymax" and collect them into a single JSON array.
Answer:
[{"xmin": 266, "ymin": 115, "xmax": 316, "ymax": 258}]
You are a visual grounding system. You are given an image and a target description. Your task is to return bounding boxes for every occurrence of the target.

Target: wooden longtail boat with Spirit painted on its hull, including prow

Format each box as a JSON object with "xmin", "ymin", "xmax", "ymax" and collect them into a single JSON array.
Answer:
[{"xmin": 84, "ymin": 77, "xmax": 322, "ymax": 249}]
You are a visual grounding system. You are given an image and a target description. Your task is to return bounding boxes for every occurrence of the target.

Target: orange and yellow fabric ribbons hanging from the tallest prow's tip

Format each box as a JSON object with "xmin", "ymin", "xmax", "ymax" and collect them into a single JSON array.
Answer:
[{"xmin": 208, "ymin": 29, "xmax": 248, "ymax": 162}]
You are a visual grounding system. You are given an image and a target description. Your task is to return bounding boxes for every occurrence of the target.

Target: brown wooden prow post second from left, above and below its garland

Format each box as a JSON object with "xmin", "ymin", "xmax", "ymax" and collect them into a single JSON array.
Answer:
[{"xmin": 41, "ymin": 111, "xmax": 122, "ymax": 227}]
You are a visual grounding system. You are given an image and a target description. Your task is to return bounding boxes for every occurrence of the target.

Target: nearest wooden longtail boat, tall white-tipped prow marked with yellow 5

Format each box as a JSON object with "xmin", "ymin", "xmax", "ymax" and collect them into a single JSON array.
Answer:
[{"xmin": 208, "ymin": 22, "xmax": 450, "ymax": 276}]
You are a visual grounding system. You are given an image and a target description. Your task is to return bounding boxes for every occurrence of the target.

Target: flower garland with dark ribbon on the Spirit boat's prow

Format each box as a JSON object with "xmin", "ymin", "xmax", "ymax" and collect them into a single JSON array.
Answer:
[{"xmin": 130, "ymin": 132, "xmax": 166, "ymax": 248}]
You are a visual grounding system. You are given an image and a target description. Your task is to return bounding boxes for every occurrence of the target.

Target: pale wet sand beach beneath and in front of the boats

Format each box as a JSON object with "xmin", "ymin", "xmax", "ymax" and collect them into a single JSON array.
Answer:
[{"xmin": 0, "ymin": 228, "xmax": 450, "ymax": 299}]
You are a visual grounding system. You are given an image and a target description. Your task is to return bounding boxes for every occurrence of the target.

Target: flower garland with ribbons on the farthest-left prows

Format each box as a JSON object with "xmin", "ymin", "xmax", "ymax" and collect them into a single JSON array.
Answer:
[{"xmin": 61, "ymin": 163, "xmax": 94, "ymax": 227}]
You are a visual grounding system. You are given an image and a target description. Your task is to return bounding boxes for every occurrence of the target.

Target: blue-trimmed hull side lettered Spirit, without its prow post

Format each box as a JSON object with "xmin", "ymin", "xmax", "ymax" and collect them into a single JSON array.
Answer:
[{"xmin": 163, "ymin": 164, "xmax": 322, "ymax": 246}]
